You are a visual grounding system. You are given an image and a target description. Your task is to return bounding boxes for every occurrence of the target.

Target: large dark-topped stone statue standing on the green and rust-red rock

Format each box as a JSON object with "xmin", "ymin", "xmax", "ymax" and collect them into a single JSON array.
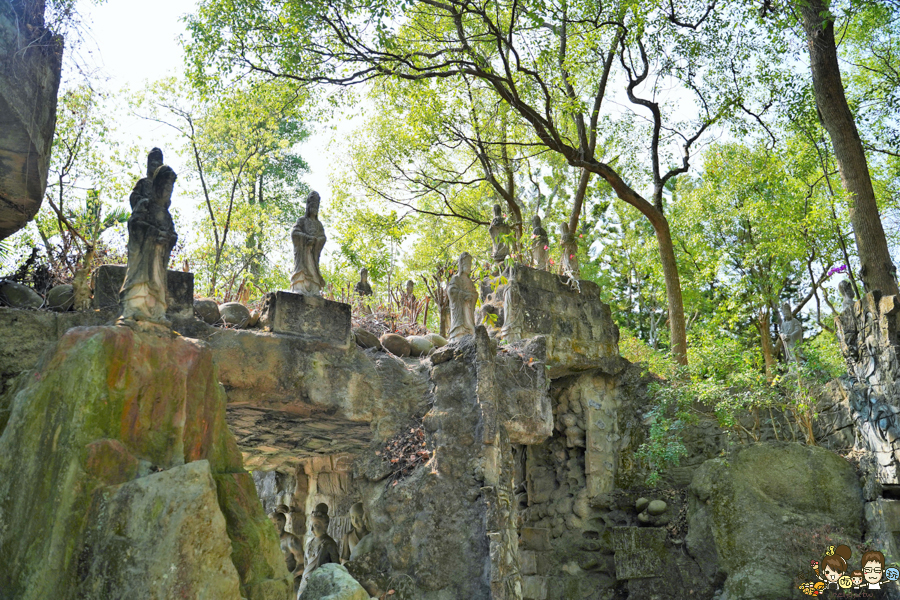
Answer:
[{"xmin": 120, "ymin": 148, "xmax": 178, "ymax": 323}]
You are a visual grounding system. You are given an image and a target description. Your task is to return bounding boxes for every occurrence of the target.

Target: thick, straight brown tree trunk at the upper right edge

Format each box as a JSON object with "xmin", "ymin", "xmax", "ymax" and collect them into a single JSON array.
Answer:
[{"xmin": 796, "ymin": 0, "xmax": 900, "ymax": 295}]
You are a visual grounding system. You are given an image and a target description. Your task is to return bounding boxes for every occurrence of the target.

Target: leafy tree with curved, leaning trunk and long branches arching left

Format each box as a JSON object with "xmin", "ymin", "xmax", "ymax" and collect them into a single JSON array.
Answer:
[{"xmin": 188, "ymin": 0, "xmax": 736, "ymax": 363}]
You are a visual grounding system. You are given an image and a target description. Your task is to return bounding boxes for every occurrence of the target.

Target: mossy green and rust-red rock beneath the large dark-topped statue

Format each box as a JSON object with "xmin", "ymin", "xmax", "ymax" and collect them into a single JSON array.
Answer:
[{"xmin": 0, "ymin": 327, "xmax": 291, "ymax": 600}]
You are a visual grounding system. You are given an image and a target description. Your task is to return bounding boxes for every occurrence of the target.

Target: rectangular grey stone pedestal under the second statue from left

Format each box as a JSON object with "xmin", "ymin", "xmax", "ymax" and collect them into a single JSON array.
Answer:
[{"xmin": 262, "ymin": 291, "xmax": 351, "ymax": 345}]
